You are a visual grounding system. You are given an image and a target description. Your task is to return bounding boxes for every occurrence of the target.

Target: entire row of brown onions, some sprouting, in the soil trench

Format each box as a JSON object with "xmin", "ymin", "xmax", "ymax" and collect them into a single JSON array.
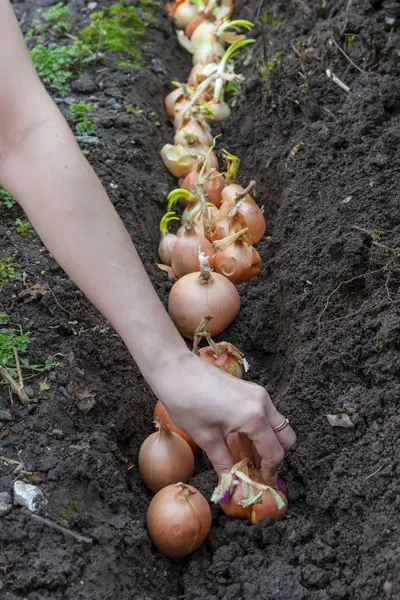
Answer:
[{"xmin": 139, "ymin": 0, "xmax": 287, "ymax": 558}]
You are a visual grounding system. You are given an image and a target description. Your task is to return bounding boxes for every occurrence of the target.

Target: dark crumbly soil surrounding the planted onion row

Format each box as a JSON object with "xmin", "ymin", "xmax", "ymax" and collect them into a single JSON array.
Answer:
[{"xmin": 0, "ymin": 0, "xmax": 400, "ymax": 600}]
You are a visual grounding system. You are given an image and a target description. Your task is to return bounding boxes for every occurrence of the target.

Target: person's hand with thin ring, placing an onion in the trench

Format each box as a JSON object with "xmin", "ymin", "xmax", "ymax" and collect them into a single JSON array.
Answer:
[{"xmin": 153, "ymin": 353, "xmax": 296, "ymax": 482}]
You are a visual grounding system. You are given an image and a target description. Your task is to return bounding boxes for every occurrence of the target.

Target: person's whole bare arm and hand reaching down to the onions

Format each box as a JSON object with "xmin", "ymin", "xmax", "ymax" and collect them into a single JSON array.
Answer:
[{"xmin": 0, "ymin": 0, "xmax": 295, "ymax": 477}]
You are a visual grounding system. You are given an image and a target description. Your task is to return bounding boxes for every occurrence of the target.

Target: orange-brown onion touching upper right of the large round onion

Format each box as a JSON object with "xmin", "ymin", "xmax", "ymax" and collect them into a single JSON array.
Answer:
[{"xmin": 214, "ymin": 228, "xmax": 261, "ymax": 283}]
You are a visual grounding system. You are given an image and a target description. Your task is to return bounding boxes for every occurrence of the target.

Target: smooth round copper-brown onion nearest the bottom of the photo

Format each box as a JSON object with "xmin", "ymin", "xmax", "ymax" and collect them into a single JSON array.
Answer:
[{"xmin": 147, "ymin": 483, "xmax": 211, "ymax": 558}]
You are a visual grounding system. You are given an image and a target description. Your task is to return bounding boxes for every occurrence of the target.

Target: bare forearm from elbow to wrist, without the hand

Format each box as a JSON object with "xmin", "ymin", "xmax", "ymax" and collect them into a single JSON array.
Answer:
[{"xmin": 0, "ymin": 109, "xmax": 188, "ymax": 385}]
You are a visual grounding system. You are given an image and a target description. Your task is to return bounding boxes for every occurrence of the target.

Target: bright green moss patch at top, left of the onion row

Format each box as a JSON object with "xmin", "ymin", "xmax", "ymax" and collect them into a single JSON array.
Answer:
[{"xmin": 80, "ymin": 0, "xmax": 159, "ymax": 67}]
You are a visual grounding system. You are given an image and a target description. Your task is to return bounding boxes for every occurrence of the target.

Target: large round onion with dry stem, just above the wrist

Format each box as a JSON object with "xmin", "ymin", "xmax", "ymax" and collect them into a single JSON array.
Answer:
[{"xmin": 168, "ymin": 252, "xmax": 240, "ymax": 339}]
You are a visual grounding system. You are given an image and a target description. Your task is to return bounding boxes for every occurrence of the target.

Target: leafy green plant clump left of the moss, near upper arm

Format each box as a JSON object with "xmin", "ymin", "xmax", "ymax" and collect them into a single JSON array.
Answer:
[{"xmin": 31, "ymin": 42, "xmax": 92, "ymax": 96}]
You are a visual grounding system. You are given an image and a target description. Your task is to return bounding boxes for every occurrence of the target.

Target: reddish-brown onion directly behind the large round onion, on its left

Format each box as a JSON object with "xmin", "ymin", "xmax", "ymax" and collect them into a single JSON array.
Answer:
[{"xmin": 171, "ymin": 219, "xmax": 214, "ymax": 279}]
